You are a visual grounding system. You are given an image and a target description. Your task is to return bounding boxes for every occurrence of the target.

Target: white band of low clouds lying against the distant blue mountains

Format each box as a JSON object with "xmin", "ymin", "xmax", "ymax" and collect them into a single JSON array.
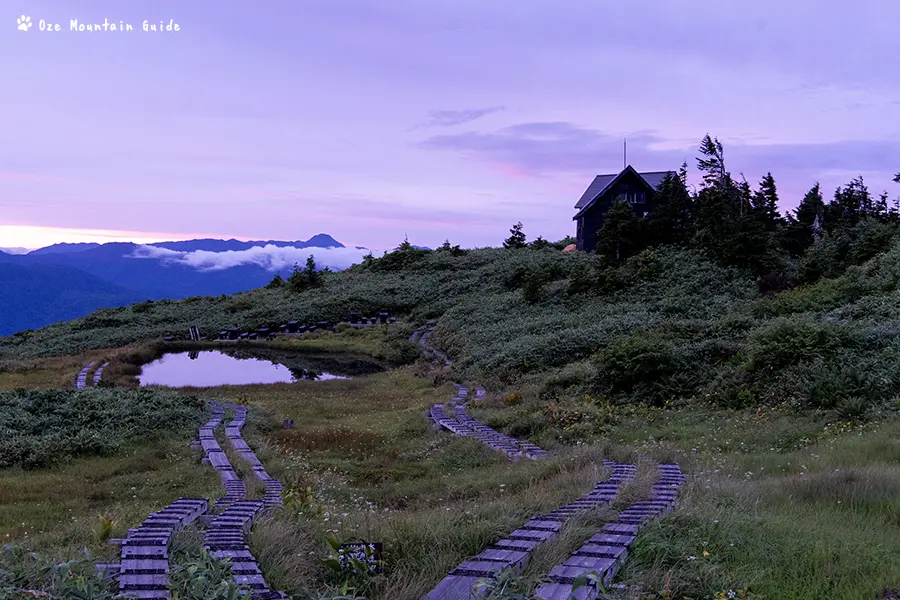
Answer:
[{"xmin": 131, "ymin": 245, "xmax": 369, "ymax": 272}]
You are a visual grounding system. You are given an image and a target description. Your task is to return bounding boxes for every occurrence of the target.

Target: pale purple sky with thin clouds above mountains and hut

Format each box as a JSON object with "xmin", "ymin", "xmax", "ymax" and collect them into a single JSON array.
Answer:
[{"xmin": 0, "ymin": 0, "xmax": 900, "ymax": 248}]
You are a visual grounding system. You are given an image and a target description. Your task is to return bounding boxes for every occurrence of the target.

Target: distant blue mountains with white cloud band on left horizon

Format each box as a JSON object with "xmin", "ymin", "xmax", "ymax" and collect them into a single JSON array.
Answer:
[{"xmin": 0, "ymin": 233, "xmax": 363, "ymax": 336}]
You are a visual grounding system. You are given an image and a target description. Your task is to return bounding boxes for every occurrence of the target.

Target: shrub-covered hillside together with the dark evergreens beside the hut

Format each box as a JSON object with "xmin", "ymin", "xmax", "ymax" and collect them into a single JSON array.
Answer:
[{"xmin": 0, "ymin": 136, "xmax": 900, "ymax": 418}]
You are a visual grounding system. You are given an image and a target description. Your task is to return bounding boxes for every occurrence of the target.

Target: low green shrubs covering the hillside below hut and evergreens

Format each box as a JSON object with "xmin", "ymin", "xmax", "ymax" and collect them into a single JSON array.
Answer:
[{"xmin": 0, "ymin": 239, "xmax": 900, "ymax": 422}]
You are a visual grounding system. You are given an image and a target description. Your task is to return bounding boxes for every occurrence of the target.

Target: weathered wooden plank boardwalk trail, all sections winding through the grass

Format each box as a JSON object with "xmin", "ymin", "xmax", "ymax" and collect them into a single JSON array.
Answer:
[{"xmin": 82, "ymin": 321, "xmax": 686, "ymax": 600}]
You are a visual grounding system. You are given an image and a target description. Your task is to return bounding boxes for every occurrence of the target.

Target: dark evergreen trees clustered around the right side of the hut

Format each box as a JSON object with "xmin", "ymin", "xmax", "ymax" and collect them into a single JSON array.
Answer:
[{"xmin": 584, "ymin": 135, "xmax": 900, "ymax": 290}]
